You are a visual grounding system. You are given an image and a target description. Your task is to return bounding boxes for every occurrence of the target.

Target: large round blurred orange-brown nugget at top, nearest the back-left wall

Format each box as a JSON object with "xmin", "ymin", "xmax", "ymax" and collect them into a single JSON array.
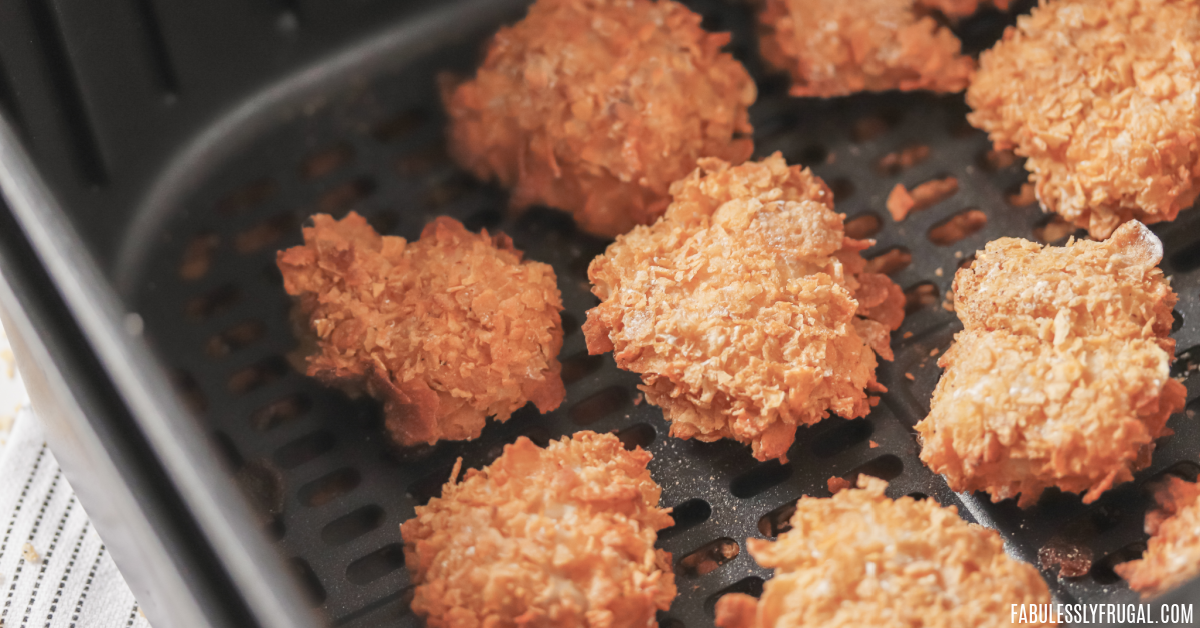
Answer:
[{"xmin": 445, "ymin": 0, "xmax": 757, "ymax": 237}]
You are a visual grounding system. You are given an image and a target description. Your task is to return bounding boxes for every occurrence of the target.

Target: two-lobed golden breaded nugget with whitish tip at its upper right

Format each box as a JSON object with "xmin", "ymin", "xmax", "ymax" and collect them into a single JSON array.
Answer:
[{"xmin": 917, "ymin": 222, "xmax": 1187, "ymax": 507}]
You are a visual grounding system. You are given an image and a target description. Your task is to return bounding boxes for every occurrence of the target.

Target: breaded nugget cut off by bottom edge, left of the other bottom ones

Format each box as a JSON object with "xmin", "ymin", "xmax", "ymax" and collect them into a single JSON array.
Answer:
[{"xmin": 400, "ymin": 432, "xmax": 676, "ymax": 628}]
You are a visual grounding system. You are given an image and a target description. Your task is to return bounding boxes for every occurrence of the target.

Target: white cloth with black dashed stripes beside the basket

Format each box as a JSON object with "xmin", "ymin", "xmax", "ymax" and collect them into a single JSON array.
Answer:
[{"xmin": 0, "ymin": 329, "xmax": 150, "ymax": 628}]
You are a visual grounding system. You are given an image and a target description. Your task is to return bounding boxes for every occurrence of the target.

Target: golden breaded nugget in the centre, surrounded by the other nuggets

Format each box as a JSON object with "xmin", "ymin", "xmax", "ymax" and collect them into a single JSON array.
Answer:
[{"xmin": 583, "ymin": 152, "xmax": 905, "ymax": 460}]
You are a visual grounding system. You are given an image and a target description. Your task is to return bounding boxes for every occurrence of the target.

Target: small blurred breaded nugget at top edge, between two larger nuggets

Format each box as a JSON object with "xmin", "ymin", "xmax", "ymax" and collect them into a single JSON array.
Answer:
[{"xmin": 758, "ymin": 0, "xmax": 974, "ymax": 97}]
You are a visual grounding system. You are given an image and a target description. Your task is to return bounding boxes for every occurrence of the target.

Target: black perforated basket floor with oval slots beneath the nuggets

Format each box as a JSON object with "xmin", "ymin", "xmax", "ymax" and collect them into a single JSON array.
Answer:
[{"xmin": 129, "ymin": 0, "xmax": 1200, "ymax": 628}]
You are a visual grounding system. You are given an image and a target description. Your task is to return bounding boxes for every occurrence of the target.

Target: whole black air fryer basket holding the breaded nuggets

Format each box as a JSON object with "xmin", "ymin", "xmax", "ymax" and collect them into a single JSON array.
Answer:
[{"xmin": 0, "ymin": 0, "xmax": 1200, "ymax": 628}]
